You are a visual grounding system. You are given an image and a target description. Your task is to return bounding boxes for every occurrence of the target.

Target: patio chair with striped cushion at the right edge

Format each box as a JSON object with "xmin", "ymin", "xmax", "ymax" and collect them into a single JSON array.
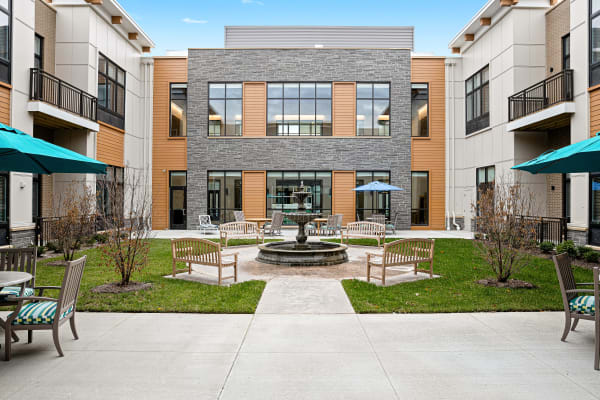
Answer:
[{"xmin": 552, "ymin": 253, "xmax": 600, "ymax": 370}]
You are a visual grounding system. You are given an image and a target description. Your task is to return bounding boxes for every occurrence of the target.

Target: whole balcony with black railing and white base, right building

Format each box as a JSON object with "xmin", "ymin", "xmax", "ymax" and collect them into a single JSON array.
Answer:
[{"xmin": 507, "ymin": 69, "xmax": 575, "ymax": 131}]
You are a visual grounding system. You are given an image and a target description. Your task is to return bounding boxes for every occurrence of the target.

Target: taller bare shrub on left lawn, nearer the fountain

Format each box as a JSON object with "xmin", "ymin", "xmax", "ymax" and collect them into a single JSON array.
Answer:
[{"xmin": 97, "ymin": 169, "xmax": 151, "ymax": 286}]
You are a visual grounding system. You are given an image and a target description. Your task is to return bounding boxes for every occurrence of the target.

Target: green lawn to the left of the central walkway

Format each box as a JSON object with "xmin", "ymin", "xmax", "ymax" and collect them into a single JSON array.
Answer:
[{"xmin": 15, "ymin": 239, "xmax": 274, "ymax": 313}]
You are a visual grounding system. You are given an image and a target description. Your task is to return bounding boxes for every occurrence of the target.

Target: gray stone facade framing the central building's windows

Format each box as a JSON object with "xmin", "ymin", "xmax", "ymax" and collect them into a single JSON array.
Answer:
[{"xmin": 187, "ymin": 49, "xmax": 411, "ymax": 229}]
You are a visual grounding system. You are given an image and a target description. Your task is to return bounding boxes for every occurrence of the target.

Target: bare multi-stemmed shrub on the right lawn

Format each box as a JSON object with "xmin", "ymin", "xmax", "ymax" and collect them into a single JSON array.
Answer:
[{"xmin": 473, "ymin": 178, "xmax": 536, "ymax": 282}]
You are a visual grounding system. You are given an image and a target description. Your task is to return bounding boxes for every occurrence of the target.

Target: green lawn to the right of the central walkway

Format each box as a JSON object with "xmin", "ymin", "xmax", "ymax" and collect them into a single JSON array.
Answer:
[{"xmin": 331, "ymin": 239, "xmax": 592, "ymax": 313}]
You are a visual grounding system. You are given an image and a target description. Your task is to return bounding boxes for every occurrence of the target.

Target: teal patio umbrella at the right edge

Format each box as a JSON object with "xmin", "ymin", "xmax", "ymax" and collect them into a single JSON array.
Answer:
[{"xmin": 512, "ymin": 132, "xmax": 600, "ymax": 174}]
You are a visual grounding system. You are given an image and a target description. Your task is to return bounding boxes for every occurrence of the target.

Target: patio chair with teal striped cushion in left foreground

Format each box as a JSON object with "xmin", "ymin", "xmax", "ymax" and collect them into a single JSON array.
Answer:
[{"xmin": 4, "ymin": 256, "xmax": 87, "ymax": 361}]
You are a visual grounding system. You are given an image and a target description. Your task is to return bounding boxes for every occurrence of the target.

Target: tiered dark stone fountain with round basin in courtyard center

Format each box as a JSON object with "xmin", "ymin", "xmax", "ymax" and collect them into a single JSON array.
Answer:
[{"xmin": 256, "ymin": 183, "xmax": 348, "ymax": 267}]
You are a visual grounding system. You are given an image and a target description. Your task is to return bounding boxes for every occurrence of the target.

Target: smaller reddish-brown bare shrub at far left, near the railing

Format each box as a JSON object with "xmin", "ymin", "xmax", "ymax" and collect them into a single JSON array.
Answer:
[{"xmin": 51, "ymin": 182, "xmax": 95, "ymax": 261}]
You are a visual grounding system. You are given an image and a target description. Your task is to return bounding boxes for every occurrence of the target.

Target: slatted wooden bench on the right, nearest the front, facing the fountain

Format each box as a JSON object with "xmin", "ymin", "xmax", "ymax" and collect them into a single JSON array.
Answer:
[{"xmin": 367, "ymin": 239, "xmax": 435, "ymax": 286}]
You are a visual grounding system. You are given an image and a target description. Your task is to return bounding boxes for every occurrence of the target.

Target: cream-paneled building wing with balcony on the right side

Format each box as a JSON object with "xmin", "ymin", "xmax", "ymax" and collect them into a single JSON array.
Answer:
[{"xmin": 446, "ymin": 0, "xmax": 600, "ymax": 245}]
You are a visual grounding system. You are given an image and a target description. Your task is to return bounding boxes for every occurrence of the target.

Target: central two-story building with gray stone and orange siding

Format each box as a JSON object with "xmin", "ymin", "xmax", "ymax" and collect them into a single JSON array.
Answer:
[{"xmin": 152, "ymin": 26, "xmax": 446, "ymax": 229}]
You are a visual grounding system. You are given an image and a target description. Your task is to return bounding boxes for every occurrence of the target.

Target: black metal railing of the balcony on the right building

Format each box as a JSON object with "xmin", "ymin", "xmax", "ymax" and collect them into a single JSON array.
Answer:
[{"xmin": 508, "ymin": 69, "xmax": 573, "ymax": 121}]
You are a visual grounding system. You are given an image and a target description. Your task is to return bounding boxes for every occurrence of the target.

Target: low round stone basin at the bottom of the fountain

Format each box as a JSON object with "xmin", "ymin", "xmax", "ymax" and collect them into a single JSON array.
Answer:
[{"xmin": 256, "ymin": 242, "xmax": 348, "ymax": 267}]
